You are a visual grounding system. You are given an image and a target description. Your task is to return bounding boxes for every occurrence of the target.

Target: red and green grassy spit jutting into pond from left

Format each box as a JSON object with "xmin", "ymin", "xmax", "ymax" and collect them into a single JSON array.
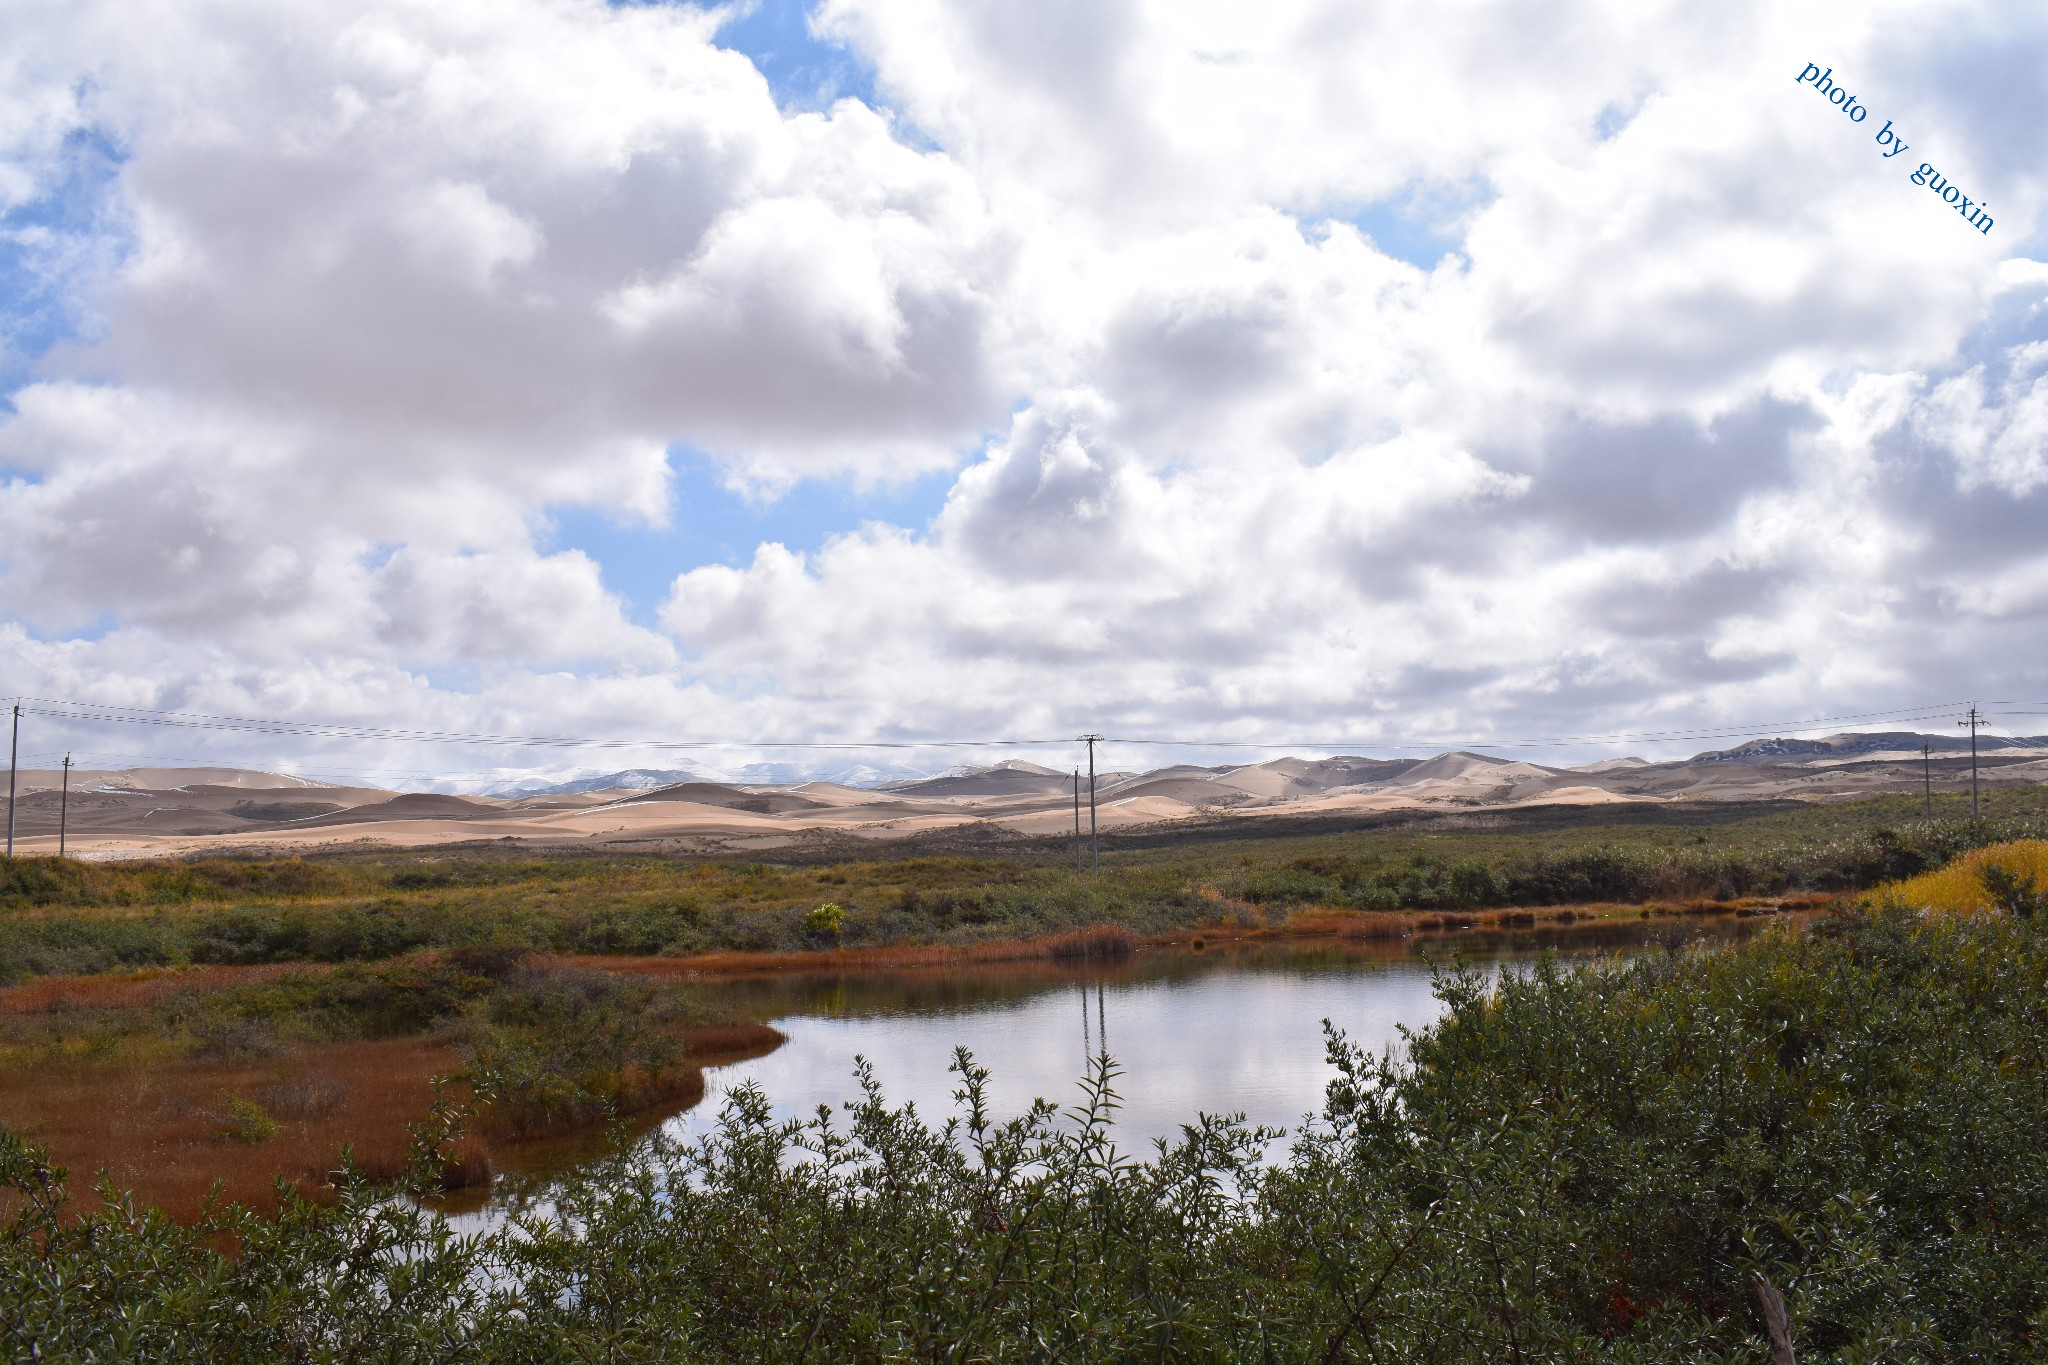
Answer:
[{"xmin": 0, "ymin": 948, "xmax": 780, "ymax": 1218}]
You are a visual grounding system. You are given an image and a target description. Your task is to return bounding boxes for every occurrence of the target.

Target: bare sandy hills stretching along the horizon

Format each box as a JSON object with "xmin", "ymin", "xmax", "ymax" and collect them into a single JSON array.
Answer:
[{"xmin": 16, "ymin": 731, "xmax": 2048, "ymax": 855}]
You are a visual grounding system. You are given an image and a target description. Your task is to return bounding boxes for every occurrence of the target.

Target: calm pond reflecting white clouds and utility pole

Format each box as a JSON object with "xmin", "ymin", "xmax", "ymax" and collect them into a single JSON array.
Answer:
[{"xmin": 451, "ymin": 919, "xmax": 1767, "ymax": 1212}]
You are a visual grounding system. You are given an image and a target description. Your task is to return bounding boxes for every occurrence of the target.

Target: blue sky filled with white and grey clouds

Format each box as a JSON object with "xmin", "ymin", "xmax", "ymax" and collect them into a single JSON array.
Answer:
[{"xmin": 0, "ymin": 0, "xmax": 2048, "ymax": 780}]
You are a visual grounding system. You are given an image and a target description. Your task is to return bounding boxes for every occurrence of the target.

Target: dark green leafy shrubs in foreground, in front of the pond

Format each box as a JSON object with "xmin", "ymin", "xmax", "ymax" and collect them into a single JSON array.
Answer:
[{"xmin": 0, "ymin": 909, "xmax": 2048, "ymax": 1361}]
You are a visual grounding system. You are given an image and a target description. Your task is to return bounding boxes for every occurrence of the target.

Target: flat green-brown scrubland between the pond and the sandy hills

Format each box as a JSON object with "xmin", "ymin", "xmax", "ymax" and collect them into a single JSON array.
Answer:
[{"xmin": 0, "ymin": 790, "xmax": 2048, "ymax": 984}]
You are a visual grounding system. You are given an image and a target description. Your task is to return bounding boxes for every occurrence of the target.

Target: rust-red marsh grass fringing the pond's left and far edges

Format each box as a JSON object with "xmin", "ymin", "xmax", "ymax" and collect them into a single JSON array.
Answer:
[{"xmin": 0, "ymin": 894, "xmax": 1847, "ymax": 1218}]
